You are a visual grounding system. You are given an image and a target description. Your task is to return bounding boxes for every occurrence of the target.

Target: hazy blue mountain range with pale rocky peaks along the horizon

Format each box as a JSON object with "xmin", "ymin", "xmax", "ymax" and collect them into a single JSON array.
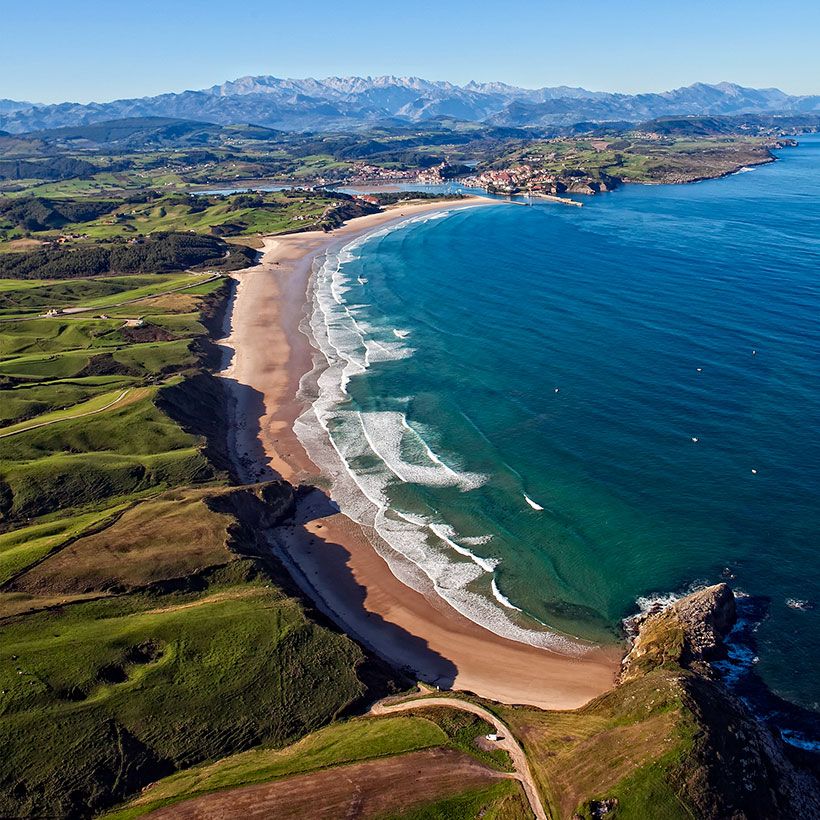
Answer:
[{"xmin": 0, "ymin": 76, "xmax": 820, "ymax": 133}]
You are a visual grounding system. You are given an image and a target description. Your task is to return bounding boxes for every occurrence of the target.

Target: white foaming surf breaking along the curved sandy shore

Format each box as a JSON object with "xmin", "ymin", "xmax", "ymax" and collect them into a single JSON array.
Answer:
[{"xmin": 294, "ymin": 213, "xmax": 588, "ymax": 656}]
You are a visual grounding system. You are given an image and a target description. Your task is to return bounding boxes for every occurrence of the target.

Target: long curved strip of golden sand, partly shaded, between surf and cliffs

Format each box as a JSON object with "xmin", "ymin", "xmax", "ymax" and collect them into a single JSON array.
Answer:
[{"xmin": 222, "ymin": 198, "xmax": 622, "ymax": 709}]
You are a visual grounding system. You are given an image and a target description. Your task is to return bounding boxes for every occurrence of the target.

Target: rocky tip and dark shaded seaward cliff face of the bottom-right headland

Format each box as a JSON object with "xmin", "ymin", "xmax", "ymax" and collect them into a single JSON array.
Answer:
[{"xmin": 620, "ymin": 584, "xmax": 820, "ymax": 820}]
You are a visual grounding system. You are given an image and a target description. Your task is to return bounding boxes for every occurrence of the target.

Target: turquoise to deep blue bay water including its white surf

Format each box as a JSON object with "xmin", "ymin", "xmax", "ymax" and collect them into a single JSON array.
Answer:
[{"xmin": 300, "ymin": 137, "xmax": 820, "ymax": 708}]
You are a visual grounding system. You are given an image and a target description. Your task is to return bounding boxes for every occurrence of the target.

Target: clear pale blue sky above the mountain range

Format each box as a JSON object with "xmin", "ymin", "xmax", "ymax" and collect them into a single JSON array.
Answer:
[{"xmin": 0, "ymin": 0, "xmax": 820, "ymax": 102}]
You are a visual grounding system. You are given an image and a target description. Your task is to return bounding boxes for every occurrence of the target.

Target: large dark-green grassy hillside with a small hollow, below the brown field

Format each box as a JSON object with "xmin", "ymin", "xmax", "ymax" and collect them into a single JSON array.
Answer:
[{"xmin": 0, "ymin": 562, "xmax": 362, "ymax": 815}]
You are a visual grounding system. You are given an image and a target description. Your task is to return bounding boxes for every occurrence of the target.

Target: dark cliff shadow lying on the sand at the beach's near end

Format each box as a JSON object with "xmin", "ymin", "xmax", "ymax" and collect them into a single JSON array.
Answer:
[{"xmin": 270, "ymin": 487, "xmax": 458, "ymax": 689}]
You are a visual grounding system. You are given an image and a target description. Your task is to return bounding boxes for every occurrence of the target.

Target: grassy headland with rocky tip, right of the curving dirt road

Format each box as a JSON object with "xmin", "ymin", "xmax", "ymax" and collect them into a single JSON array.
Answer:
[{"xmin": 506, "ymin": 584, "xmax": 820, "ymax": 820}]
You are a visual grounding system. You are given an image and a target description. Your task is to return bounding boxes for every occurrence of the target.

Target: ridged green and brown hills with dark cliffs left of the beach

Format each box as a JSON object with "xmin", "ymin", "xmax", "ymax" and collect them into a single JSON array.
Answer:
[{"xmin": 0, "ymin": 274, "xmax": 394, "ymax": 816}]
